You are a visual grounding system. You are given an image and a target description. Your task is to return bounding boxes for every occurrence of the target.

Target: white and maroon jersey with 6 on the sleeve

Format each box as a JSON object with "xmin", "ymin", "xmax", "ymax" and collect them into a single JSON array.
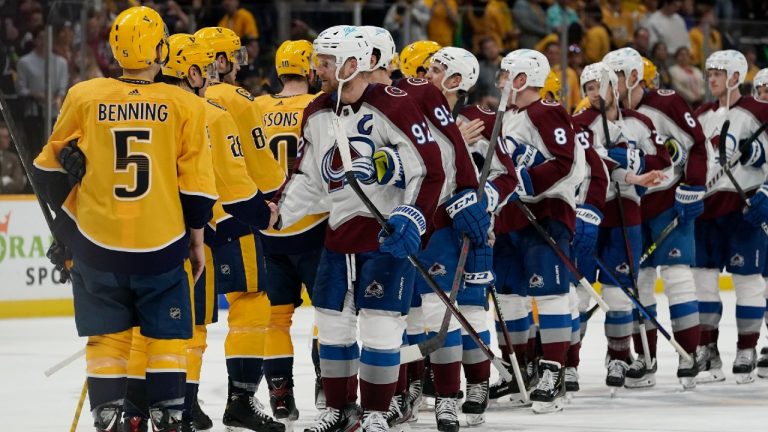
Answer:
[{"xmin": 635, "ymin": 90, "xmax": 707, "ymax": 220}]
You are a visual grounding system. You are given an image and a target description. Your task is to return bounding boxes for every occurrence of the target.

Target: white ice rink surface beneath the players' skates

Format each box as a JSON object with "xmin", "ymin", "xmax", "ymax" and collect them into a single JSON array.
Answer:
[{"xmin": 0, "ymin": 291, "xmax": 768, "ymax": 432}]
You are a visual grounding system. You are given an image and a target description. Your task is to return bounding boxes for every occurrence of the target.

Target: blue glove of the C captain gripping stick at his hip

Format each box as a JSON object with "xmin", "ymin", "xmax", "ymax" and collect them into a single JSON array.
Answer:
[{"xmin": 379, "ymin": 205, "xmax": 427, "ymax": 258}]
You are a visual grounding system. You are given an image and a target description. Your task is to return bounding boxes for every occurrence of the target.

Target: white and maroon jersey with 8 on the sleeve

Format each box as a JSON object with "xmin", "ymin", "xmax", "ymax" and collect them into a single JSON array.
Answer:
[{"xmin": 499, "ymin": 100, "xmax": 586, "ymax": 231}]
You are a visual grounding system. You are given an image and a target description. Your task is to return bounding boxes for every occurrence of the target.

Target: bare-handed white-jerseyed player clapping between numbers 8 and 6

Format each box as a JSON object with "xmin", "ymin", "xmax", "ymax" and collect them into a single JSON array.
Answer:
[{"xmin": 573, "ymin": 62, "xmax": 670, "ymax": 388}]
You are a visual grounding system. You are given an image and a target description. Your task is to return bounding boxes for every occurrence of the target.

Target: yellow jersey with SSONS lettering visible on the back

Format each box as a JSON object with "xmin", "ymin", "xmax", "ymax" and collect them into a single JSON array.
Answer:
[{"xmin": 250, "ymin": 94, "xmax": 328, "ymax": 254}]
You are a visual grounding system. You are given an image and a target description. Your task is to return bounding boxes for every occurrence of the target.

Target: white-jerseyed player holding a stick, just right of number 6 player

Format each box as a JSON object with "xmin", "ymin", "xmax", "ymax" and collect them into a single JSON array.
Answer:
[{"xmin": 694, "ymin": 50, "xmax": 768, "ymax": 383}]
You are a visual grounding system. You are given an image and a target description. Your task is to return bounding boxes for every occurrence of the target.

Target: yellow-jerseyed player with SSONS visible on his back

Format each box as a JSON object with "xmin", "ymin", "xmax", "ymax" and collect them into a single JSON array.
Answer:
[{"xmin": 255, "ymin": 40, "xmax": 328, "ymax": 422}]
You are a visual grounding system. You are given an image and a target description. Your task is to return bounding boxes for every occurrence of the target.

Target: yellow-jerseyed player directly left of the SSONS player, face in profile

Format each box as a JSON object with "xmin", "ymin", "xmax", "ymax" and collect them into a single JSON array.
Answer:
[{"xmin": 195, "ymin": 27, "xmax": 285, "ymax": 430}]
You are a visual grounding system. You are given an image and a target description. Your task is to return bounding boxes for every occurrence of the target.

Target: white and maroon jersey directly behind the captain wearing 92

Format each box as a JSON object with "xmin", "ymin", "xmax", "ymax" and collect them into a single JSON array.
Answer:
[{"xmin": 393, "ymin": 78, "xmax": 477, "ymax": 233}]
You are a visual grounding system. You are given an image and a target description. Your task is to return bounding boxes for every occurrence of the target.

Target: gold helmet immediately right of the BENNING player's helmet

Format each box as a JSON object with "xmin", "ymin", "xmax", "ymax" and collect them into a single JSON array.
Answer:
[{"xmin": 163, "ymin": 33, "xmax": 216, "ymax": 81}]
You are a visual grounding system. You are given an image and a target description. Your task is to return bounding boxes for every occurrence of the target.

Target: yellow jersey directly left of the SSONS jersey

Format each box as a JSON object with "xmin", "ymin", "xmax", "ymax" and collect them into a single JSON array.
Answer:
[{"xmin": 205, "ymin": 83, "xmax": 285, "ymax": 193}]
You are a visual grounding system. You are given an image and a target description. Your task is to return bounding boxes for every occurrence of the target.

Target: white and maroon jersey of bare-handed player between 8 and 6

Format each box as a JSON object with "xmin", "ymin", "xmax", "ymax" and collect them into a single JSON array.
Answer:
[{"xmin": 573, "ymin": 107, "xmax": 671, "ymax": 227}]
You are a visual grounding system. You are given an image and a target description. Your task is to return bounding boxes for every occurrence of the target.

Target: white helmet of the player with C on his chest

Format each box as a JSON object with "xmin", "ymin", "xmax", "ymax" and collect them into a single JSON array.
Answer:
[{"xmin": 312, "ymin": 25, "xmax": 373, "ymax": 83}]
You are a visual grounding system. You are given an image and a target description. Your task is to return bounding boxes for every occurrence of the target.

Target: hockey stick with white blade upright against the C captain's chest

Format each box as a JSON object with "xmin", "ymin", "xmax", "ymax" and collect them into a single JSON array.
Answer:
[{"xmin": 331, "ymin": 114, "xmax": 512, "ymax": 381}]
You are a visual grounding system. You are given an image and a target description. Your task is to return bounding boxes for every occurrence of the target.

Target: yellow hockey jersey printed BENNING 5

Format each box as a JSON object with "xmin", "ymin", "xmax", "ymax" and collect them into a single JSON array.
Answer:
[{"xmin": 34, "ymin": 78, "xmax": 217, "ymax": 274}]
